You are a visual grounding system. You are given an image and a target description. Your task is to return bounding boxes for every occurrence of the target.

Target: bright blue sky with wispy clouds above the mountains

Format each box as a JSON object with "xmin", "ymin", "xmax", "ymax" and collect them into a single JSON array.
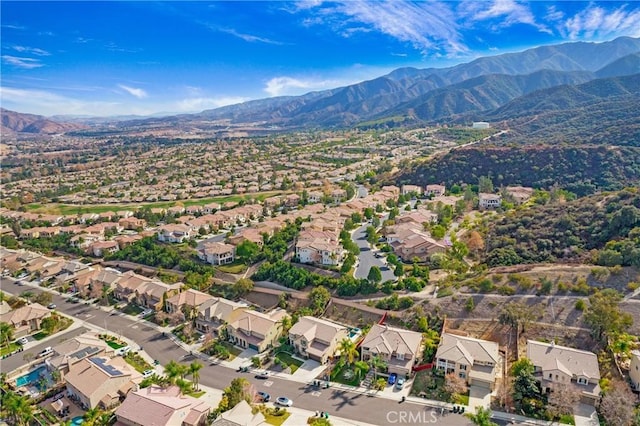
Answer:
[{"xmin": 0, "ymin": 0, "xmax": 640, "ymax": 116}]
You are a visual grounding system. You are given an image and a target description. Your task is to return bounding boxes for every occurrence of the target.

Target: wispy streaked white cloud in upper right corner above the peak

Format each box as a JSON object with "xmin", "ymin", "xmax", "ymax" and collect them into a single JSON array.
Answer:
[{"xmin": 558, "ymin": 5, "xmax": 640, "ymax": 40}]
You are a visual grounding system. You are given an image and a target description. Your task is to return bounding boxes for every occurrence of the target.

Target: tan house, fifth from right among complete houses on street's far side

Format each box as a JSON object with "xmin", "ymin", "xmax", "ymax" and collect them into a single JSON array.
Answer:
[{"xmin": 227, "ymin": 308, "xmax": 287, "ymax": 352}]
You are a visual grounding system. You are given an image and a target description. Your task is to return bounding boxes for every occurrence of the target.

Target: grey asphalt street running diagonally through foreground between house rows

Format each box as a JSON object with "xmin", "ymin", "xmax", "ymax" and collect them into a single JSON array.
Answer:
[{"xmin": 2, "ymin": 279, "xmax": 482, "ymax": 426}]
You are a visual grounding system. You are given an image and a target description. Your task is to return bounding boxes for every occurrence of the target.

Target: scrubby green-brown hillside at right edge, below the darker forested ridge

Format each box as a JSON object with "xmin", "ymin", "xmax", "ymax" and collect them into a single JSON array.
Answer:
[{"xmin": 485, "ymin": 188, "xmax": 640, "ymax": 266}]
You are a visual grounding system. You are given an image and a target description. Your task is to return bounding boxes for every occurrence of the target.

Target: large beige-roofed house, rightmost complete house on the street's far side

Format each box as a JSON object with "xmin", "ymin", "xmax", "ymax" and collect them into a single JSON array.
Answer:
[{"xmin": 527, "ymin": 340, "xmax": 600, "ymax": 406}]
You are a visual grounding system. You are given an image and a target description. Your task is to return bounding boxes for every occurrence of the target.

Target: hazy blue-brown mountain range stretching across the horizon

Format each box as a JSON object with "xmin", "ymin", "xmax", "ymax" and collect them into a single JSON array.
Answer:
[{"xmin": 2, "ymin": 37, "xmax": 640, "ymax": 133}]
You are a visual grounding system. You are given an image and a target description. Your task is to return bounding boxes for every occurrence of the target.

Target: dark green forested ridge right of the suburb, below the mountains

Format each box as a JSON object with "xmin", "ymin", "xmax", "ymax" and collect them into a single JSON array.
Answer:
[{"xmin": 395, "ymin": 145, "xmax": 640, "ymax": 196}]
